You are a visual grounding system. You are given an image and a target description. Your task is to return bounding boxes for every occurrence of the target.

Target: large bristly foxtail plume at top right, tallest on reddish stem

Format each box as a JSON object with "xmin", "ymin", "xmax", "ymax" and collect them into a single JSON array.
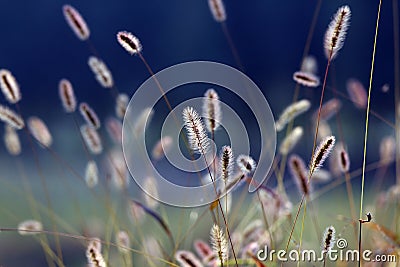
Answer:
[{"xmin": 324, "ymin": 6, "xmax": 351, "ymax": 60}]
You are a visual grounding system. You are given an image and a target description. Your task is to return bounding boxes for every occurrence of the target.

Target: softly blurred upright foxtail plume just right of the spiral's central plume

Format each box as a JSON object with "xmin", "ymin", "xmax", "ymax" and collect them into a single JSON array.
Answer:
[{"xmin": 203, "ymin": 89, "xmax": 221, "ymax": 133}]
